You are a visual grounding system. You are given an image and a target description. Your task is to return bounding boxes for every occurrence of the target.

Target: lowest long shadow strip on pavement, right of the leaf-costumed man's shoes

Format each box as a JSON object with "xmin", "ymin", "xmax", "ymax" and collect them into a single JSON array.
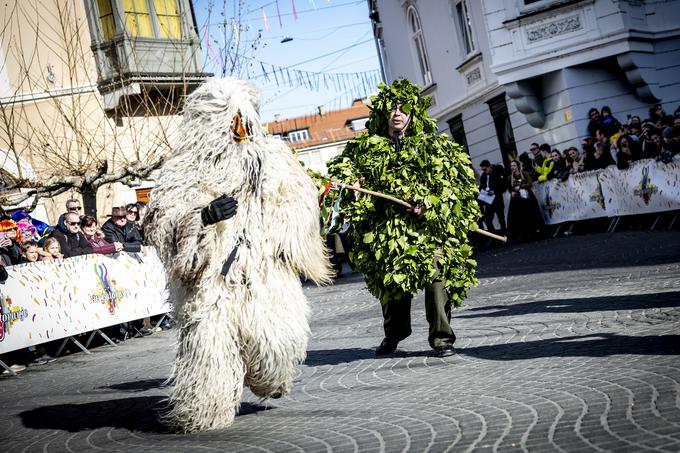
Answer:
[{"xmin": 456, "ymin": 333, "xmax": 680, "ymax": 360}]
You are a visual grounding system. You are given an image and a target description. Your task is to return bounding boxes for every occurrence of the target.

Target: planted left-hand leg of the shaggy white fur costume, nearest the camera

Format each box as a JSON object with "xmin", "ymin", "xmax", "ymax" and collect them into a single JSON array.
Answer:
[{"xmin": 168, "ymin": 299, "xmax": 245, "ymax": 432}]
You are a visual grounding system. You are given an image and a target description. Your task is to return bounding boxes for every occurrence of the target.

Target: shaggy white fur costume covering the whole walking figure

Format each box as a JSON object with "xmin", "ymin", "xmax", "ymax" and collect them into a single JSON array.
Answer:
[{"xmin": 145, "ymin": 79, "xmax": 331, "ymax": 432}]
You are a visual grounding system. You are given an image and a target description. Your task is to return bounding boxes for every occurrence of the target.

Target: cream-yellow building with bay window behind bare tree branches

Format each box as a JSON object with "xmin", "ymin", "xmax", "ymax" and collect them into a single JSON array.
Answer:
[{"xmin": 0, "ymin": 0, "xmax": 209, "ymax": 223}]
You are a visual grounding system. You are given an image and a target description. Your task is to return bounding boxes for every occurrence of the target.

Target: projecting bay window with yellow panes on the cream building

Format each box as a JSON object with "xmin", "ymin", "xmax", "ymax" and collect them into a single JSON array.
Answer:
[{"xmin": 84, "ymin": 0, "xmax": 212, "ymax": 113}]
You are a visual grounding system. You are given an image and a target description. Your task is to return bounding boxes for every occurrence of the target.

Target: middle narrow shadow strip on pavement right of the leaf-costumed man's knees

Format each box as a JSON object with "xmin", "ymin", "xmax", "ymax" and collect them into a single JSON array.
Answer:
[{"xmin": 455, "ymin": 291, "xmax": 680, "ymax": 319}]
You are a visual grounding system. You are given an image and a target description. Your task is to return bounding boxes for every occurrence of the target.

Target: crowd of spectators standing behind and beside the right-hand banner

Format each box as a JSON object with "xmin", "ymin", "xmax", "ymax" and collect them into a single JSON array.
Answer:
[{"xmin": 479, "ymin": 104, "xmax": 680, "ymax": 239}]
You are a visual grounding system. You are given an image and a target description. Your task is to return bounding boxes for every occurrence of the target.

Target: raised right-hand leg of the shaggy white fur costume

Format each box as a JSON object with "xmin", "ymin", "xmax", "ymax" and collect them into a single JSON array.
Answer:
[{"xmin": 242, "ymin": 266, "xmax": 309, "ymax": 398}]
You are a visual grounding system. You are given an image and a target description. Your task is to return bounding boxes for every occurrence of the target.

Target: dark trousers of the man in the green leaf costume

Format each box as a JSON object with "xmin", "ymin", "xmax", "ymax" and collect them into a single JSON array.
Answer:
[{"xmin": 382, "ymin": 281, "xmax": 456, "ymax": 348}]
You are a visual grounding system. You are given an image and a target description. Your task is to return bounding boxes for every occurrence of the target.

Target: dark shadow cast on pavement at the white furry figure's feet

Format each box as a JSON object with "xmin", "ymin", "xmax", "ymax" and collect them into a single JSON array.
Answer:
[{"xmin": 19, "ymin": 396, "xmax": 273, "ymax": 434}]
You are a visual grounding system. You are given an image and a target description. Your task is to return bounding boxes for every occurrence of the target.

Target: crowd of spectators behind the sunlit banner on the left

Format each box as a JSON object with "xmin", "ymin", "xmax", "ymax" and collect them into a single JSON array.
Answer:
[{"xmin": 0, "ymin": 199, "xmax": 172, "ymax": 371}]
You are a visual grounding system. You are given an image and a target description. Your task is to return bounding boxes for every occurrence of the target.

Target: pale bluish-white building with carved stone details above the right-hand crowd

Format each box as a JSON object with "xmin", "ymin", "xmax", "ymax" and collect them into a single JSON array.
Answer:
[{"xmin": 368, "ymin": 0, "xmax": 680, "ymax": 167}]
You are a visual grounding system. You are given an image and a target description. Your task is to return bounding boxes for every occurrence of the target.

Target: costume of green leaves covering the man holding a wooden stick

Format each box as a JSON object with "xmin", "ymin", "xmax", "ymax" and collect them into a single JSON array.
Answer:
[{"xmin": 328, "ymin": 79, "xmax": 481, "ymax": 305}]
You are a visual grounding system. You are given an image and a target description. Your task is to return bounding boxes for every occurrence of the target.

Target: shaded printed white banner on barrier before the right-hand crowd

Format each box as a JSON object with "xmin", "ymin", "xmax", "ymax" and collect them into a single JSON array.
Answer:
[{"xmin": 534, "ymin": 158, "xmax": 680, "ymax": 225}]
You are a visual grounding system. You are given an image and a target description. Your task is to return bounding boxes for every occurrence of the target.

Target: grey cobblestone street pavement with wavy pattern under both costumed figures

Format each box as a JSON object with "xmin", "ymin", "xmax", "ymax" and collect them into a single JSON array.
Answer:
[{"xmin": 0, "ymin": 232, "xmax": 680, "ymax": 452}]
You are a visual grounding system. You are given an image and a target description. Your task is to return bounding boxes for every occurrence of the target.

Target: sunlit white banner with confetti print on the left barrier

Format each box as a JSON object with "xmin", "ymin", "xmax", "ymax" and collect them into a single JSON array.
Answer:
[{"xmin": 0, "ymin": 247, "xmax": 170, "ymax": 354}]
